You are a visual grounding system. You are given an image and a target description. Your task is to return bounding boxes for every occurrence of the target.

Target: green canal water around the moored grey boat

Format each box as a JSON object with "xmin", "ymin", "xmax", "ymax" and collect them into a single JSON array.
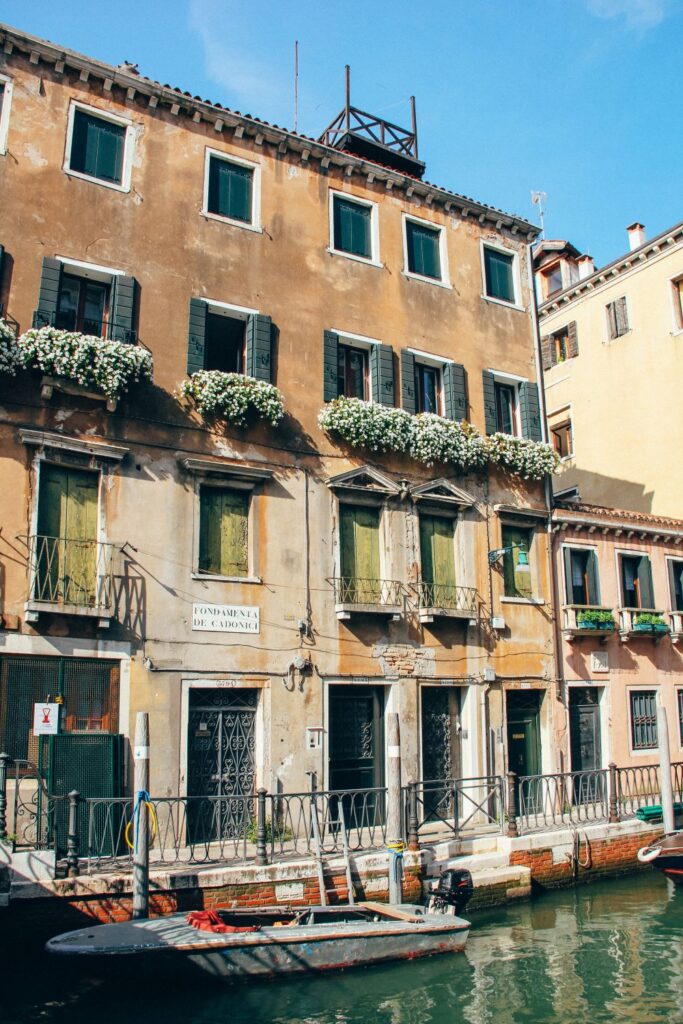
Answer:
[{"xmin": 0, "ymin": 872, "xmax": 683, "ymax": 1024}]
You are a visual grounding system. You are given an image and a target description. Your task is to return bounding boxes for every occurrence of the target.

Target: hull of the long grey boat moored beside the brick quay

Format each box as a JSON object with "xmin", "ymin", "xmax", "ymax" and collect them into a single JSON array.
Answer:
[{"xmin": 46, "ymin": 907, "xmax": 469, "ymax": 980}]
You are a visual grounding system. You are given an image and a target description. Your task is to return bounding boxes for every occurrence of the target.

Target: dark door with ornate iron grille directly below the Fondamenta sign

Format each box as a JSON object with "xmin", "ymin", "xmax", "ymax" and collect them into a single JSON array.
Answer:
[{"xmin": 187, "ymin": 688, "xmax": 258, "ymax": 843}]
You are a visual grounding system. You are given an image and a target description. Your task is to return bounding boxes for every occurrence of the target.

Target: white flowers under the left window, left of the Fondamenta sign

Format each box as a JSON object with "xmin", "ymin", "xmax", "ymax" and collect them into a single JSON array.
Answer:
[{"xmin": 17, "ymin": 327, "xmax": 154, "ymax": 401}]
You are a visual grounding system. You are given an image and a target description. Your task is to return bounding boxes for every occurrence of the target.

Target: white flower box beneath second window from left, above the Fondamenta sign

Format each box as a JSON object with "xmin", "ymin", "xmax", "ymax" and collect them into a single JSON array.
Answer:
[{"xmin": 178, "ymin": 370, "xmax": 285, "ymax": 427}]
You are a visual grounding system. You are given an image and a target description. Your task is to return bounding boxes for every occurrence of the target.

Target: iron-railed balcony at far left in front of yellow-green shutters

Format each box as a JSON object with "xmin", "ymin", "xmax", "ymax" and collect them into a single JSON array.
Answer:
[{"xmin": 26, "ymin": 535, "xmax": 116, "ymax": 627}]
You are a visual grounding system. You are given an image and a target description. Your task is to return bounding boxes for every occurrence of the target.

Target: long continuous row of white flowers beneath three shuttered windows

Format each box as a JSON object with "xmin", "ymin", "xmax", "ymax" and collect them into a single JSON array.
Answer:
[{"xmin": 317, "ymin": 397, "xmax": 559, "ymax": 480}]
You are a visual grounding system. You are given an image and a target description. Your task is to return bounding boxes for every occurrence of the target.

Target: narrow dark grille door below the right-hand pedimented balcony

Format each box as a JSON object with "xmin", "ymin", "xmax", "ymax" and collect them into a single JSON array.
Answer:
[{"xmin": 422, "ymin": 686, "xmax": 461, "ymax": 821}]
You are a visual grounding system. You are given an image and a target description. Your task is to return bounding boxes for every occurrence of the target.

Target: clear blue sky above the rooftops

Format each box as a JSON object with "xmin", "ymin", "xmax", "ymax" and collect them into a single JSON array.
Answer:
[{"xmin": 0, "ymin": 0, "xmax": 683, "ymax": 263}]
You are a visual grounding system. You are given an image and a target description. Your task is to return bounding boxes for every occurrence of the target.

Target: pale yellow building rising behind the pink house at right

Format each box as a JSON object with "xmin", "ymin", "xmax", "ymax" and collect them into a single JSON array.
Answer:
[{"xmin": 535, "ymin": 223, "xmax": 683, "ymax": 517}]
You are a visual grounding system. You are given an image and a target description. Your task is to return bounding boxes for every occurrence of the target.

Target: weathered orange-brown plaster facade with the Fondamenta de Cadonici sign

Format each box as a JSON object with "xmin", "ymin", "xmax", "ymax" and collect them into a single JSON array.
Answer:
[{"xmin": 0, "ymin": 28, "xmax": 563, "ymax": 823}]
